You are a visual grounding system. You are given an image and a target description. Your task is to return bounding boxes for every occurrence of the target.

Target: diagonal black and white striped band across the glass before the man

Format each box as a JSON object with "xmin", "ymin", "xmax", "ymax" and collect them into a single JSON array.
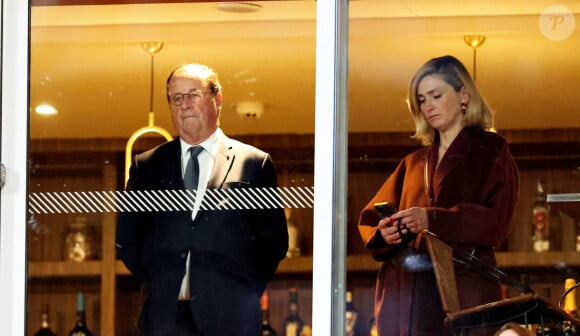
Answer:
[{"xmin": 28, "ymin": 187, "xmax": 314, "ymax": 214}]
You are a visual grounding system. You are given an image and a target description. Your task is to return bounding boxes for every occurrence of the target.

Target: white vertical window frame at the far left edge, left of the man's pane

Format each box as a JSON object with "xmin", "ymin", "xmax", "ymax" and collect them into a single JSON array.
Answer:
[{"xmin": 0, "ymin": 0, "xmax": 29, "ymax": 335}]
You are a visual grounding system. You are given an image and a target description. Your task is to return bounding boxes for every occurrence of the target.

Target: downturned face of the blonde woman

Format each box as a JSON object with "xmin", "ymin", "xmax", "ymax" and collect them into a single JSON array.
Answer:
[{"xmin": 417, "ymin": 75, "xmax": 469, "ymax": 132}]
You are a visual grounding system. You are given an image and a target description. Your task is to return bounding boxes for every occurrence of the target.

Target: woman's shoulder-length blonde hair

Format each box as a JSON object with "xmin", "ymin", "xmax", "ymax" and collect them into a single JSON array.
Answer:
[{"xmin": 407, "ymin": 56, "xmax": 492, "ymax": 146}]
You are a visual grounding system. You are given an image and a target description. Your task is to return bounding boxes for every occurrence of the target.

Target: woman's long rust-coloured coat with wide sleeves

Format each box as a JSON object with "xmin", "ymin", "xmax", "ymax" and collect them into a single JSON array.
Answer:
[{"xmin": 358, "ymin": 127, "xmax": 519, "ymax": 336}]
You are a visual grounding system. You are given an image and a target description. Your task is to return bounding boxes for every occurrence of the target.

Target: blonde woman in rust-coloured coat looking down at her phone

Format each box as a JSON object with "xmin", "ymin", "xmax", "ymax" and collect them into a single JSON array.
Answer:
[{"xmin": 358, "ymin": 56, "xmax": 519, "ymax": 336}]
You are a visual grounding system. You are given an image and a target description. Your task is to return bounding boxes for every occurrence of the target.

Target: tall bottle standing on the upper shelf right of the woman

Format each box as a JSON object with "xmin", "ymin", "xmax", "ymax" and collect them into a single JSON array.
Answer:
[{"xmin": 532, "ymin": 180, "xmax": 550, "ymax": 252}]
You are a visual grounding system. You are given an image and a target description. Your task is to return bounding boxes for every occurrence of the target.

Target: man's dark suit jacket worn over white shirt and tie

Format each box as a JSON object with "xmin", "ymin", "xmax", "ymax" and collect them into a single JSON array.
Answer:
[{"xmin": 116, "ymin": 136, "xmax": 288, "ymax": 336}]
